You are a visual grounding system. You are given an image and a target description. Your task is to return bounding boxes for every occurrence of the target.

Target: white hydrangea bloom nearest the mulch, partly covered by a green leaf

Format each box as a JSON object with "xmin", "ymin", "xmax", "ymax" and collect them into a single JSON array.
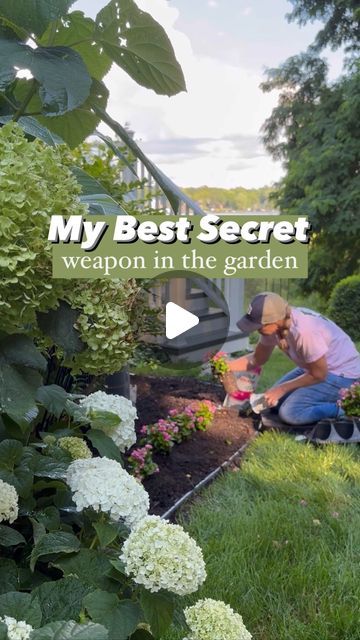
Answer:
[{"xmin": 80, "ymin": 391, "xmax": 137, "ymax": 452}]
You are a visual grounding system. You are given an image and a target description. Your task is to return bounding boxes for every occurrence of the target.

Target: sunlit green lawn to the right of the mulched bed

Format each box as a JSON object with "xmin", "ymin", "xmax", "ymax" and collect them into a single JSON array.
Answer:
[{"xmin": 164, "ymin": 433, "xmax": 360, "ymax": 640}]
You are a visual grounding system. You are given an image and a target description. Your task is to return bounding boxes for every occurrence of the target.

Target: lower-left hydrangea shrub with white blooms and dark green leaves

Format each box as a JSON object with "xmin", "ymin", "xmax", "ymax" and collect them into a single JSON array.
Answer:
[{"xmin": 0, "ymin": 393, "xmax": 247, "ymax": 640}]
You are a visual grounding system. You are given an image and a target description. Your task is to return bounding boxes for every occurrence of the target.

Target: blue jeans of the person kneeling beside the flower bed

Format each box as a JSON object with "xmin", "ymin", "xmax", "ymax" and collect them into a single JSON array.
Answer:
[{"xmin": 273, "ymin": 367, "xmax": 357, "ymax": 425}]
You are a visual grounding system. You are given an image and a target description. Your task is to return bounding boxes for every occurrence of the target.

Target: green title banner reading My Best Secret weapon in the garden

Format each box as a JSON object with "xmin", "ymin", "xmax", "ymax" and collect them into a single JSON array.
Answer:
[{"xmin": 49, "ymin": 214, "xmax": 309, "ymax": 279}]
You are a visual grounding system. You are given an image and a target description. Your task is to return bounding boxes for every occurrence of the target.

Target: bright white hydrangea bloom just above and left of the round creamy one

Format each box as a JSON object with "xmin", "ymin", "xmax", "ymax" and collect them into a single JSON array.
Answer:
[{"xmin": 66, "ymin": 458, "xmax": 149, "ymax": 528}]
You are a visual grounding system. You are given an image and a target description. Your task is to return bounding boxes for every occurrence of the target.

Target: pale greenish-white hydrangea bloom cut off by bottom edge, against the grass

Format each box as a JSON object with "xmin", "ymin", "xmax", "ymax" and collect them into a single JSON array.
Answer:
[{"xmin": 184, "ymin": 598, "xmax": 252, "ymax": 640}]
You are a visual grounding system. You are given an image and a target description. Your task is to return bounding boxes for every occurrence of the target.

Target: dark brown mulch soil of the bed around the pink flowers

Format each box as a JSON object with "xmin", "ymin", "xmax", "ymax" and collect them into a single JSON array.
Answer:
[{"xmin": 132, "ymin": 376, "xmax": 255, "ymax": 515}]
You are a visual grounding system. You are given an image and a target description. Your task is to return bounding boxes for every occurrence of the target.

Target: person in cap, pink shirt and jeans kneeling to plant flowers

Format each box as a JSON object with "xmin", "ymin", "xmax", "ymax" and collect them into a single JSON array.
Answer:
[{"xmin": 229, "ymin": 292, "xmax": 360, "ymax": 425}]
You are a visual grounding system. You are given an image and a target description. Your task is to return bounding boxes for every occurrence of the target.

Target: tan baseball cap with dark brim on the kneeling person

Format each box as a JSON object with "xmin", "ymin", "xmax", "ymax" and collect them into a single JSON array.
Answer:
[{"xmin": 236, "ymin": 291, "xmax": 288, "ymax": 333}]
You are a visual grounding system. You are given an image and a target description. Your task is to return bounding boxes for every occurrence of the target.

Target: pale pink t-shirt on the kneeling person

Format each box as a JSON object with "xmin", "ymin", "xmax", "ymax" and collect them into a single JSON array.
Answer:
[{"xmin": 260, "ymin": 307, "xmax": 360, "ymax": 378}]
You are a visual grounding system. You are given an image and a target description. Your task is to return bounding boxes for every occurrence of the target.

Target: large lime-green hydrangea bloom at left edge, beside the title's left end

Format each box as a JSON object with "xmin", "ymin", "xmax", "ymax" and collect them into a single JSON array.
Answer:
[{"xmin": 0, "ymin": 123, "xmax": 86, "ymax": 333}]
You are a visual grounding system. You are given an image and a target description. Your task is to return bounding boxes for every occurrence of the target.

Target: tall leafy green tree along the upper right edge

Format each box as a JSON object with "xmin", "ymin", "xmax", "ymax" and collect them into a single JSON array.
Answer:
[{"xmin": 262, "ymin": 0, "xmax": 360, "ymax": 296}]
